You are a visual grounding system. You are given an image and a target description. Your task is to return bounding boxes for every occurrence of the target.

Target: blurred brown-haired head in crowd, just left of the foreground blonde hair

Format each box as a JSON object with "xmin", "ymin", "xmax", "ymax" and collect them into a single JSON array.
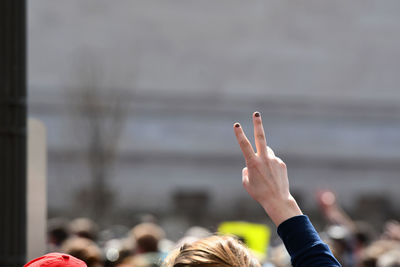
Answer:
[{"xmin": 131, "ymin": 223, "xmax": 165, "ymax": 253}]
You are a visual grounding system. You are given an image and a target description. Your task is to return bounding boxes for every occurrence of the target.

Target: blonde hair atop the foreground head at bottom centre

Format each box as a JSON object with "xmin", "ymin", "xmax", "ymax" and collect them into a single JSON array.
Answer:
[{"xmin": 163, "ymin": 236, "xmax": 261, "ymax": 267}]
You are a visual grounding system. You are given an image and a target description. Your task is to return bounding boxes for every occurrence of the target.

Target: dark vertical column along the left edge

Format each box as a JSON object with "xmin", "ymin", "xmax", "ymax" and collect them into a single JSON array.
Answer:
[{"xmin": 0, "ymin": 0, "xmax": 27, "ymax": 267}]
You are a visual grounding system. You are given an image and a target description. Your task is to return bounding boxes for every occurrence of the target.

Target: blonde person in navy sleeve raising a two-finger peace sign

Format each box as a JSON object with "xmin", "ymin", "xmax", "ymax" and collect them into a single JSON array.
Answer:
[{"xmin": 164, "ymin": 112, "xmax": 340, "ymax": 267}]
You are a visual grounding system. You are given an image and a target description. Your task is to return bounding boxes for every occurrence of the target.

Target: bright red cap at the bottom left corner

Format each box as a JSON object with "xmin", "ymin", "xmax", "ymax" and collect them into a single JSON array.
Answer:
[{"xmin": 24, "ymin": 253, "xmax": 87, "ymax": 267}]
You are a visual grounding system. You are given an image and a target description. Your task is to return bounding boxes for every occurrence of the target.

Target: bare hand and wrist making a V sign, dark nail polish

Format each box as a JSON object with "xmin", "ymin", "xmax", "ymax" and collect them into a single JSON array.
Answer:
[{"xmin": 233, "ymin": 112, "xmax": 302, "ymax": 226}]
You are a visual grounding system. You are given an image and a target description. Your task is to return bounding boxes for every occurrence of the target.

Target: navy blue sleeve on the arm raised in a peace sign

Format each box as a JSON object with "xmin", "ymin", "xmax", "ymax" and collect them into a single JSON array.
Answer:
[{"xmin": 278, "ymin": 215, "xmax": 341, "ymax": 267}]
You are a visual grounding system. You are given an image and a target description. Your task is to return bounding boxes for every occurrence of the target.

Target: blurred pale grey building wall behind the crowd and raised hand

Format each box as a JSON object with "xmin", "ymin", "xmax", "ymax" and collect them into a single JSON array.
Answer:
[{"xmin": 28, "ymin": 0, "xmax": 400, "ymax": 266}]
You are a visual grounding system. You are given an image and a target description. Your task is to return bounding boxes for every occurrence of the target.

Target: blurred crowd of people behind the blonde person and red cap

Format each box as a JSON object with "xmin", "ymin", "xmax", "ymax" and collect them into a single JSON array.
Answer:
[{"xmin": 48, "ymin": 191, "xmax": 400, "ymax": 267}]
